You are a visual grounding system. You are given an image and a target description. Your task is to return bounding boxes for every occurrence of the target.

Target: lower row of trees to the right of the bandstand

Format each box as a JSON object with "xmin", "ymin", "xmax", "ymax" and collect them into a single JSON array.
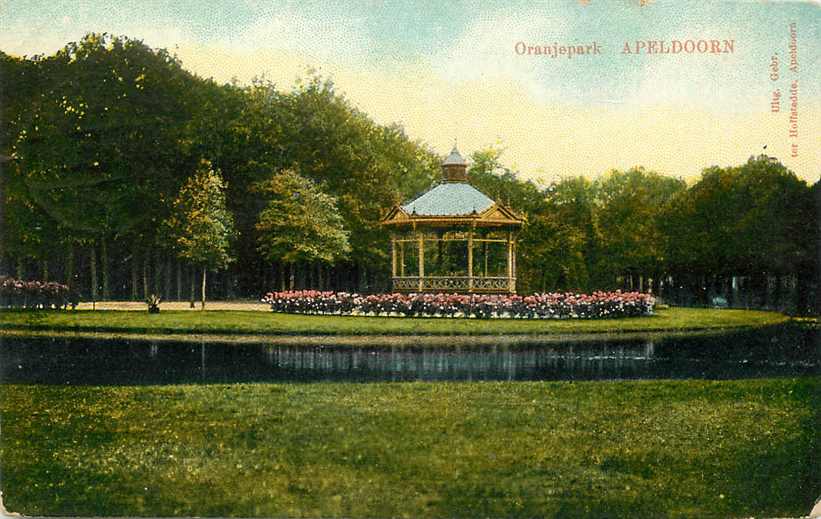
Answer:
[{"xmin": 471, "ymin": 149, "xmax": 821, "ymax": 313}]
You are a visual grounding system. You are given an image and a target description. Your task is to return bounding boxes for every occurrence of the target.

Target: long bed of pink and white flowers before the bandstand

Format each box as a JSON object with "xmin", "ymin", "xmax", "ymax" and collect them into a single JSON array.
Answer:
[{"xmin": 262, "ymin": 290, "xmax": 655, "ymax": 319}]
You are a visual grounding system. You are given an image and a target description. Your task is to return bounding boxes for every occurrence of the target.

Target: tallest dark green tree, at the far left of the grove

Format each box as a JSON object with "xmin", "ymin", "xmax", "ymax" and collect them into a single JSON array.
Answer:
[{"xmin": 8, "ymin": 33, "xmax": 194, "ymax": 295}]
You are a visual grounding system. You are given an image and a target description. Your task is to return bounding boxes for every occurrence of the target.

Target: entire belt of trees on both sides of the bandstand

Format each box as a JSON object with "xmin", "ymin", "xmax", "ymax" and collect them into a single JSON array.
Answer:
[{"xmin": 0, "ymin": 34, "xmax": 819, "ymax": 311}]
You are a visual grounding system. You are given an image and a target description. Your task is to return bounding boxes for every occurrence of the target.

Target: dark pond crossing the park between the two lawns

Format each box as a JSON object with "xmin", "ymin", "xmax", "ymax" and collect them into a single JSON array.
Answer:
[{"xmin": 0, "ymin": 326, "xmax": 821, "ymax": 385}]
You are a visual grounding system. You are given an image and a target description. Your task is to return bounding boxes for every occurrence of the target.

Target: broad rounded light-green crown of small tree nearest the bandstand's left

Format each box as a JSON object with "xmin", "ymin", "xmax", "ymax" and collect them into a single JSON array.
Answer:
[{"xmin": 256, "ymin": 170, "xmax": 351, "ymax": 264}]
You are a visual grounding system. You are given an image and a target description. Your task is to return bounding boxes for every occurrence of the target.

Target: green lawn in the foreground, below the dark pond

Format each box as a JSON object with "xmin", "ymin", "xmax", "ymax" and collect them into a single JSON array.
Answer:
[{"xmin": 0, "ymin": 379, "xmax": 821, "ymax": 517}]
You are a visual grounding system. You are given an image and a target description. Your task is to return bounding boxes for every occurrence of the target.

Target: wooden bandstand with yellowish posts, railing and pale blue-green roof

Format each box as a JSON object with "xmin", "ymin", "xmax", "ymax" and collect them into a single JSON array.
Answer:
[{"xmin": 381, "ymin": 147, "xmax": 524, "ymax": 293}]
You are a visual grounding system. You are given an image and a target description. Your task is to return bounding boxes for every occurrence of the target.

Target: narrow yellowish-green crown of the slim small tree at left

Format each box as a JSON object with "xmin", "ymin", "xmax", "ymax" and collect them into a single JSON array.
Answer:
[{"xmin": 165, "ymin": 160, "xmax": 234, "ymax": 269}]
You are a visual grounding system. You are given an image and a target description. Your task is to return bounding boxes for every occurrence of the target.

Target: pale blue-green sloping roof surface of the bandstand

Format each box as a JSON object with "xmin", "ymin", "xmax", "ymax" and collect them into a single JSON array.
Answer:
[{"xmin": 402, "ymin": 182, "xmax": 494, "ymax": 216}]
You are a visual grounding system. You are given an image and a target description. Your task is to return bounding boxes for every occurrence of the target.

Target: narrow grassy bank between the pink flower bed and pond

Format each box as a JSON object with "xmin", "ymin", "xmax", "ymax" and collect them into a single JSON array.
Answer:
[{"xmin": 0, "ymin": 308, "xmax": 788, "ymax": 335}]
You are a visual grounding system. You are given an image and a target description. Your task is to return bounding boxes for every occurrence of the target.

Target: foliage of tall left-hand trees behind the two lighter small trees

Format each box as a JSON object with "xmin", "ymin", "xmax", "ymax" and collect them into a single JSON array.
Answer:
[{"xmin": 0, "ymin": 40, "xmax": 438, "ymax": 291}]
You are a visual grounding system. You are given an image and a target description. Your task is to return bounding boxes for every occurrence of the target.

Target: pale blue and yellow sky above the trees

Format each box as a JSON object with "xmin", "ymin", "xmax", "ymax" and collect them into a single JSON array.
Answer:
[{"xmin": 0, "ymin": 0, "xmax": 821, "ymax": 182}]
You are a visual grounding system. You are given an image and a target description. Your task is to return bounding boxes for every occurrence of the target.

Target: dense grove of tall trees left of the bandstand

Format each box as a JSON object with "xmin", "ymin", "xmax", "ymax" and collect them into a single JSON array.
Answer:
[{"xmin": 0, "ymin": 34, "xmax": 438, "ymax": 306}]
